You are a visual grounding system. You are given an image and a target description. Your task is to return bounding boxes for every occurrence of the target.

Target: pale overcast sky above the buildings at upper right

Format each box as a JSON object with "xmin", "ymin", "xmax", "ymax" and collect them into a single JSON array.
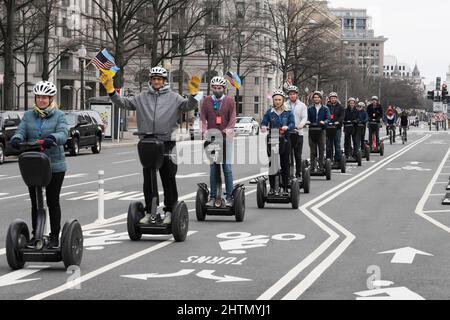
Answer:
[{"xmin": 328, "ymin": 0, "xmax": 450, "ymax": 84}]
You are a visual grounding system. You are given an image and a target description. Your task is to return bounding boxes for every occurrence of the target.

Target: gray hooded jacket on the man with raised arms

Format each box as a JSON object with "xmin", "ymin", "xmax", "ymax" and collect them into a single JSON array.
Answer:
[{"xmin": 110, "ymin": 85, "xmax": 198, "ymax": 141}]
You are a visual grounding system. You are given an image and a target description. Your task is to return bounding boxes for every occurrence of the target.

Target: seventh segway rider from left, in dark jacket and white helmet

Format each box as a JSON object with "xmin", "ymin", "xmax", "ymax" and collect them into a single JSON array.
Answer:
[{"xmin": 327, "ymin": 92, "xmax": 345, "ymax": 163}]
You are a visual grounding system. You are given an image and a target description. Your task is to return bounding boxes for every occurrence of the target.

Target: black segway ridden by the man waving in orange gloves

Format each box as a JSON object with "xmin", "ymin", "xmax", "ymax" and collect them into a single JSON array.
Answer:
[{"xmin": 127, "ymin": 132, "xmax": 189, "ymax": 242}]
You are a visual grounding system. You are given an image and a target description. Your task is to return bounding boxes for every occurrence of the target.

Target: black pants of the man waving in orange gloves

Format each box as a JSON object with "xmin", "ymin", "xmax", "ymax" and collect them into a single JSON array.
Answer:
[{"xmin": 144, "ymin": 141, "xmax": 178, "ymax": 212}]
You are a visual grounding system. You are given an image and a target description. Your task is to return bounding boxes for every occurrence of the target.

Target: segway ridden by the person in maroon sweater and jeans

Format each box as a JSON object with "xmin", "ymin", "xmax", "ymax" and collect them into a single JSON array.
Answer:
[{"xmin": 195, "ymin": 136, "xmax": 245, "ymax": 222}]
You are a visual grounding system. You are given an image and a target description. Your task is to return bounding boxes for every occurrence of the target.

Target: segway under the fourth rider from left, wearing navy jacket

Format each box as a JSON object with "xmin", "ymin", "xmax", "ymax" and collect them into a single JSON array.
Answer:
[{"xmin": 256, "ymin": 129, "xmax": 300, "ymax": 209}]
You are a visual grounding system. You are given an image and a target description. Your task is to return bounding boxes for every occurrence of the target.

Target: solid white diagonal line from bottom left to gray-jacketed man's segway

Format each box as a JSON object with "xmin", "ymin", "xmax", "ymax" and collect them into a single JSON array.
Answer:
[{"xmin": 27, "ymin": 231, "xmax": 197, "ymax": 300}]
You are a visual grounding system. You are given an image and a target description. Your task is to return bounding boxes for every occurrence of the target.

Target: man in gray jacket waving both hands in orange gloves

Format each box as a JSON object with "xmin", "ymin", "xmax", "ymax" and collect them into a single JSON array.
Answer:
[{"xmin": 100, "ymin": 67, "xmax": 200, "ymax": 224}]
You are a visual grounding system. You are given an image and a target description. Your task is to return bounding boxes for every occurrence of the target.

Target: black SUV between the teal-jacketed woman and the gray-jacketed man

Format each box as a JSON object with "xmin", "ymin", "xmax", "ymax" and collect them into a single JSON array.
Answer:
[{"xmin": 64, "ymin": 111, "xmax": 103, "ymax": 156}]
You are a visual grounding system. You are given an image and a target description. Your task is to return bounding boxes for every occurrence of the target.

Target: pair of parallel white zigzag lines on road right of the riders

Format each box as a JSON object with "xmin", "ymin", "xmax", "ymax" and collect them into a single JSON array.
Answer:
[{"xmin": 258, "ymin": 136, "xmax": 429, "ymax": 300}]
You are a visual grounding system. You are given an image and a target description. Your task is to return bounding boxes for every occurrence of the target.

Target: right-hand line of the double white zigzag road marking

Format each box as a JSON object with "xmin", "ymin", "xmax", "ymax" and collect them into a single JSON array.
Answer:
[{"xmin": 282, "ymin": 137, "xmax": 428, "ymax": 300}]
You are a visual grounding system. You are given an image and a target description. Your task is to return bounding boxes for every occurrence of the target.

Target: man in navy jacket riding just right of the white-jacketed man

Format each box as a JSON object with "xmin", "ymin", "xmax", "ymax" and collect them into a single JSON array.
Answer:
[{"xmin": 308, "ymin": 91, "xmax": 331, "ymax": 171}]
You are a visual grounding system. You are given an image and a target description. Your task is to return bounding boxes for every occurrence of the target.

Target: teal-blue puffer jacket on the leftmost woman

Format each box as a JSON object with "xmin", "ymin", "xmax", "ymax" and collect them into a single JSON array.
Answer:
[{"xmin": 11, "ymin": 110, "xmax": 68, "ymax": 172}]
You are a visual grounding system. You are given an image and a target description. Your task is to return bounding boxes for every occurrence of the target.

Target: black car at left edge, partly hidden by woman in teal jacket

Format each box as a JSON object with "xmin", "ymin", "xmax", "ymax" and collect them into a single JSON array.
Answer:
[{"xmin": 0, "ymin": 111, "xmax": 23, "ymax": 165}]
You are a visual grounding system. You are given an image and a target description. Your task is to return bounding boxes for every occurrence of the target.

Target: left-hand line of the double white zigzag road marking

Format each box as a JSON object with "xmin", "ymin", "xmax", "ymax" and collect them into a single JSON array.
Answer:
[{"xmin": 257, "ymin": 137, "xmax": 428, "ymax": 300}]
